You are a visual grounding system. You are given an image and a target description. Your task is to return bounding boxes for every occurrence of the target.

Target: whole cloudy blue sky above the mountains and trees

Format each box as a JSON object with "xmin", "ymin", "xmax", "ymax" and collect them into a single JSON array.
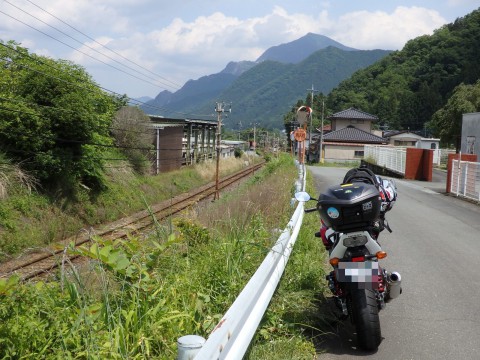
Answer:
[{"xmin": 0, "ymin": 0, "xmax": 480, "ymax": 97}]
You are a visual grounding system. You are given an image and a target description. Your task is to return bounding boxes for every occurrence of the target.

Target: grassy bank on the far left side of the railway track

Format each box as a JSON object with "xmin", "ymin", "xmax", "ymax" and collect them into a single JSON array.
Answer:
[{"xmin": 0, "ymin": 153, "xmax": 258, "ymax": 261}]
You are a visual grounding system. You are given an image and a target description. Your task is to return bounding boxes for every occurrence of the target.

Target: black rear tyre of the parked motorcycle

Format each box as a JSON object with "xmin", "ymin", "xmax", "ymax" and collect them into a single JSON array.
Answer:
[{"xmin": 350, "ymin": 289, "xmax": 382, "ymax": 351}]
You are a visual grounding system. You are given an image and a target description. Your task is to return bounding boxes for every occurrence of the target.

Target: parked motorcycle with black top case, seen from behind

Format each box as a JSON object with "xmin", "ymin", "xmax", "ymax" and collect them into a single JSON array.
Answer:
[{"xmin": 295, "ymin": 182, "xmax": 402, "ymax": 351}]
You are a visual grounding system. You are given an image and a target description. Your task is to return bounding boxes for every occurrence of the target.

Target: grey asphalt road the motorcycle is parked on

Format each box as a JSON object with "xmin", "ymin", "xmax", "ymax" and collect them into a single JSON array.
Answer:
[{"xmin": 307, "ymin": 167, "xmax": 480, "ymax": 360}]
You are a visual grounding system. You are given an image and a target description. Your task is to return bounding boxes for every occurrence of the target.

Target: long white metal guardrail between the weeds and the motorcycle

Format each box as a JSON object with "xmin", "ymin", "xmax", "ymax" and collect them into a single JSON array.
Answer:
[{"xmin": 177, "ymin": 164, "xmax": 306, "ymax": 360}]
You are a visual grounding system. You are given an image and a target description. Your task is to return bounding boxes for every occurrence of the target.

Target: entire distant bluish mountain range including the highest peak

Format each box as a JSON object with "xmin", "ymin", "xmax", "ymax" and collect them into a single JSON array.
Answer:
[{"xmin": 141, "ymin": 33, "xmax": 388, "ymax": 128}]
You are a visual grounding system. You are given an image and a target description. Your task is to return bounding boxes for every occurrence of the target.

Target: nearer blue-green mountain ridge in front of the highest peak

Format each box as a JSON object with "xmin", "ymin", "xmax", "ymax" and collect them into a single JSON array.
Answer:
[{"xmin": 198, "ymin": 47, "xmax": 389, "ymax": 128}]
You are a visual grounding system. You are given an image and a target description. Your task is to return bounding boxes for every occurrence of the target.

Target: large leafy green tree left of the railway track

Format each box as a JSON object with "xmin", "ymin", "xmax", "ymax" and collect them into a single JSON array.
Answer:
[{"xmin": 0, "ymin": 41, "xmax": 121, "ymax": 190}]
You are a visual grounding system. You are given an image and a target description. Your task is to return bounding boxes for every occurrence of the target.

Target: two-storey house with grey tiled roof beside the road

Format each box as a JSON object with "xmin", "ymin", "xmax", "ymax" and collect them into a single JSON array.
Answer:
[{"xmin": 316, "ymin": 108, "xmax": 388, "ymax": 161}]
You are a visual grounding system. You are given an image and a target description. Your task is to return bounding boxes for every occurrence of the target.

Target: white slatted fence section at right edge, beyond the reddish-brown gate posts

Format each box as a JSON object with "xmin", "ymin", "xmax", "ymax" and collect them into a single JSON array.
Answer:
[{"xmin": 450, "ymin": 160, "xmax": 480, "ymax": 202}]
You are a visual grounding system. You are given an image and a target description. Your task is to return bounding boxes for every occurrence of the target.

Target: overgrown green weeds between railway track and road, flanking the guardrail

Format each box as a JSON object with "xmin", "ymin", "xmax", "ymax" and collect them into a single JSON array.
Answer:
[{"xmin": 0, "ymin": 153, "xmax": 325, "ymax": 359}]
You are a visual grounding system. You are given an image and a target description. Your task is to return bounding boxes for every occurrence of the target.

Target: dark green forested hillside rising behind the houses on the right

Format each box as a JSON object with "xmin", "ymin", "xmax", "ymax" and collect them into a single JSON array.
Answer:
[{"xmin": 327, "ymin": 10, "xmax": 480, "ymax": 142}]
